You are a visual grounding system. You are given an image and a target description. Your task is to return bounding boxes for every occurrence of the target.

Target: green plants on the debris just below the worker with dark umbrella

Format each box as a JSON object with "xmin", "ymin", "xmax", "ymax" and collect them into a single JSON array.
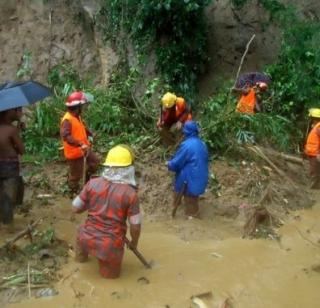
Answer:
[{"xmin": 200, "ymin": 87, "xmax": 300, "ymax": 153}]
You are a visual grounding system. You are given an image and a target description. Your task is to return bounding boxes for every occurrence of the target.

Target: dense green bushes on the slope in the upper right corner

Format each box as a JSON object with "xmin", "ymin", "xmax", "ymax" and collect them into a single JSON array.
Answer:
[{"xmin": 226, "ymin": 0, "xmax": 320, "ymax": 152}]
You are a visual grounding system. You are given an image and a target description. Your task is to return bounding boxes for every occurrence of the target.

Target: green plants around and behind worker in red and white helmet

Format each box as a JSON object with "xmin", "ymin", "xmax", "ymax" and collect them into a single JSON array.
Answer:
[{"xmin": 24, "ymin": 65, "xmax": 158, "ymax": 160}]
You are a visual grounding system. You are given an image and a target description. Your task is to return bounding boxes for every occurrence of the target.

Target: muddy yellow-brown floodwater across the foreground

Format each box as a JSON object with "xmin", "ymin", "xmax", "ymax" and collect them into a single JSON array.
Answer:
[{"xmin": 3, "ymin": 195, "xmax": 320, "ymax": 308}]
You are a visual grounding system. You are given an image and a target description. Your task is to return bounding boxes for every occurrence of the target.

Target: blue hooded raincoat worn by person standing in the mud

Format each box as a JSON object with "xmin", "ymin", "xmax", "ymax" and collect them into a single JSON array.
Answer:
[{"xmin": 168, "ymin": 121, "xmax": 209, "ymax": 196}]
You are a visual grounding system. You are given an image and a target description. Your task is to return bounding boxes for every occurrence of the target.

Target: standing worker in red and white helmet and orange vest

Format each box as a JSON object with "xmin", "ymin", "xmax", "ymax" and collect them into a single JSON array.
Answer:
[{"xmin": 60, "ymin": 91, "xmax": 99, "ymax": 194}]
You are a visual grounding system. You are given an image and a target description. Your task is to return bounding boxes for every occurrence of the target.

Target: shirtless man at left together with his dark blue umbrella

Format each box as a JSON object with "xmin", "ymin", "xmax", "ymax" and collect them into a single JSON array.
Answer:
[{"xmin": 0, "ymin": 81, "xmax": 52, "ymax": 228}]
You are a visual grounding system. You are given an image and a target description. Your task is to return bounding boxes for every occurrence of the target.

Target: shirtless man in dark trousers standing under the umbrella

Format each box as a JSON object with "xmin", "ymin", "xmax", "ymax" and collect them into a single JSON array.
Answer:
[{"xmin": 0, "ymin": 108, "xmax": 24, "ymax": 225}]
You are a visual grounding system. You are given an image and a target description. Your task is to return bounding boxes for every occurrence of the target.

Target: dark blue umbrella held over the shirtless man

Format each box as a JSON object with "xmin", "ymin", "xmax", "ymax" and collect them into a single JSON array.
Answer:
[{"xmin": 0, "ymin": 80, "xmax": 53, "ymax": 111}]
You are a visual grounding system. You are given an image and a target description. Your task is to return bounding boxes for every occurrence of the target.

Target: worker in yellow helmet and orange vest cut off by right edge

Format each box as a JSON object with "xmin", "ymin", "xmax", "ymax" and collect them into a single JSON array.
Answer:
[{"xmin": 304, "ymin": 108, "xmax": 320, "ymax": 189}]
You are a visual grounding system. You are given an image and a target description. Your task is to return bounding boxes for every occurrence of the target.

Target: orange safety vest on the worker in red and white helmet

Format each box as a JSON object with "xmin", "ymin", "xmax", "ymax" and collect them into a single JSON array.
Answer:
[{"xmin": 61, "ymin": 112, "xmax": 90, "ymax": 159}]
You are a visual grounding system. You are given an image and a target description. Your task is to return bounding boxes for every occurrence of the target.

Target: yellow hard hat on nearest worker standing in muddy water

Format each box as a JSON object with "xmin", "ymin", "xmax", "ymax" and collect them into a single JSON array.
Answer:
[{"xmin": 103, "ymin": 145, "xmax": 133, "ymax": 167}]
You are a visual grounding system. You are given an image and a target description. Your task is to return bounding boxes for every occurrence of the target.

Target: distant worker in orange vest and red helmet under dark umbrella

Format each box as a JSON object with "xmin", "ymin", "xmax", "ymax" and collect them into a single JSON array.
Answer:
[{"xmin": 233, "ymin": 82, "xmax": 268, "ymax": 115}]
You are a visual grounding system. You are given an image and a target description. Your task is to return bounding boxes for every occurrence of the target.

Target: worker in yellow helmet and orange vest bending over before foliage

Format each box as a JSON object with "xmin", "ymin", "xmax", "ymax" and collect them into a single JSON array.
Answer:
[{"xmin": 157, "ymin": 92, "xmax": 192, "ymax": 144}]
